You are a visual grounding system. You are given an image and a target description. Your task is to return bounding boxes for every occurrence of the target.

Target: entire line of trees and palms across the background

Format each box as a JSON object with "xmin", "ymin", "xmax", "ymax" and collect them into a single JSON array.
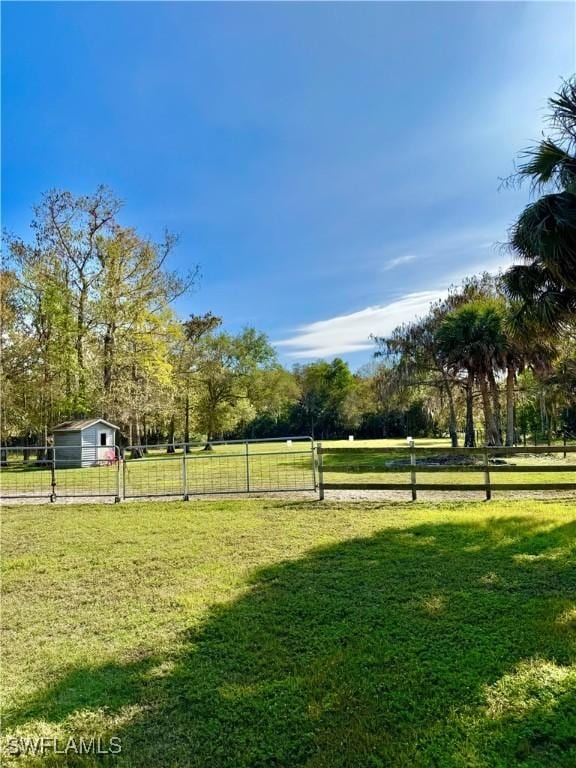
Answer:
[{"xmin": 0, "ymin": 80, "xmax": 576, "ymax": 450}]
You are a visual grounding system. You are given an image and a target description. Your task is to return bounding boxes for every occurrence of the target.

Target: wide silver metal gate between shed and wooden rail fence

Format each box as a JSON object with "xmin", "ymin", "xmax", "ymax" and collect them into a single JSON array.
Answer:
[{"xmin": 122, "ymin": 437, "xmax": 317, "ymax": 499}]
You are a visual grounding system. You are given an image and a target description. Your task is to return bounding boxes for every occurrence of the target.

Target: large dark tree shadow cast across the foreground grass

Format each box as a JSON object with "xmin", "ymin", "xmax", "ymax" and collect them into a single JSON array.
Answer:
[{"xmin": 5, "ymin": 518, "xmax": 576, "ymax": 768}]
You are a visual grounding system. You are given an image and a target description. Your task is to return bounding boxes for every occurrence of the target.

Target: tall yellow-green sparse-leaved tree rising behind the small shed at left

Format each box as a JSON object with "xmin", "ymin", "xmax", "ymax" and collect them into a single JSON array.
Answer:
[{"xmin": 1, "ymin": 187, "xmax": 194, "ymax": 443}]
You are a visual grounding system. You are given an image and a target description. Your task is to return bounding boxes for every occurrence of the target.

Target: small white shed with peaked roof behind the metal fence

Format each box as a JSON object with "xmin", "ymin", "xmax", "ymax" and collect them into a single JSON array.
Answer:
[{"xmin": 52, "ymin": 419, "xmax": 118, "ymax": 468}]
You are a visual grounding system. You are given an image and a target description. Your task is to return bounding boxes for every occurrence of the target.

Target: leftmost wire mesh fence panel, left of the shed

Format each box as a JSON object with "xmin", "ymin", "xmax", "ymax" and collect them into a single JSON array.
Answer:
[{"xmin": 0, "ymin": 446, "xmax": 52, "ymax": 499}]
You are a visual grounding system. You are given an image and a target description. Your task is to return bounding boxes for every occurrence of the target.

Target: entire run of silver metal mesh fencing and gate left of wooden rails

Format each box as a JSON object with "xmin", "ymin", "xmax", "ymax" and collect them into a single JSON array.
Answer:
[{"xmin": 0, "ymin": 438, "xmax": 316, "ymax": 500}]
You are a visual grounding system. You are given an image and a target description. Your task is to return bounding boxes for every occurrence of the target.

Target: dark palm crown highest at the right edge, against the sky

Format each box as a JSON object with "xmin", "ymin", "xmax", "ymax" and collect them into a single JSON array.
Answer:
[{"xmin": 504, "ymin": 78, "xmax": 576, "ymax": 330}]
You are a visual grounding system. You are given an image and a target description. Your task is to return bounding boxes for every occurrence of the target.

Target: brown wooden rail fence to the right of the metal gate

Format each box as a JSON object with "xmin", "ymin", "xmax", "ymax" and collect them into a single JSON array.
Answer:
[{"xmin": 317, "ymin": 443, "xmax": 576, "ymax": 501}]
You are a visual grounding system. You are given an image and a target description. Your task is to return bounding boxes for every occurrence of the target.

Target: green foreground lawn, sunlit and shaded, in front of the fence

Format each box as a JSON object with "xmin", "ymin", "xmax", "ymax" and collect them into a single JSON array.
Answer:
[{"xmin": 2, "ymin": 500, "xmax": 576, "ymax": 768}]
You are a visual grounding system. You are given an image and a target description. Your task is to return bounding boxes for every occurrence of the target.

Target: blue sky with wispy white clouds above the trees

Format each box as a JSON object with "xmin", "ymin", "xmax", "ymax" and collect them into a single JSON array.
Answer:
[{"xmin": 2, "ymin": 2, "xmax": 576, "ymax": 366}]
